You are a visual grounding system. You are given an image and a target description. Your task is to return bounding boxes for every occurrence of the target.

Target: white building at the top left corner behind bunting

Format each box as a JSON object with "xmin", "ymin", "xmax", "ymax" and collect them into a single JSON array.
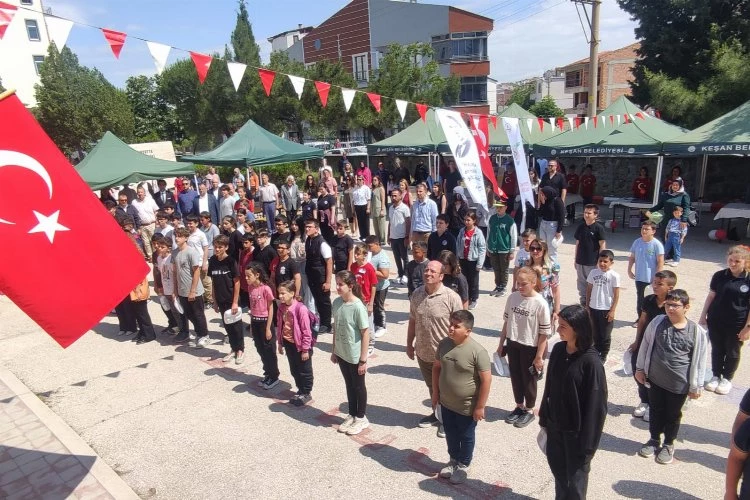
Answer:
[{"xmin": 0, "ymin": 0, "xmax": 49, "ymax": 107}]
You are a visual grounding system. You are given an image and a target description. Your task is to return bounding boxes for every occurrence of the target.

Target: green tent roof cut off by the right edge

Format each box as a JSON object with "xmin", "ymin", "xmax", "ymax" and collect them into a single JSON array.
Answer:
[{"xmin": 664, "ymin": 101, "xmax": 750, "ymax": 155}]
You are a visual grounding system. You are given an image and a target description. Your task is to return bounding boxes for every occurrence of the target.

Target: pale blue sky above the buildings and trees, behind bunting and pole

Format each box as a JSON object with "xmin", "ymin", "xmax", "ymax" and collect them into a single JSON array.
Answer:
[{"xmin": 44, "ymin": 0, "xmax": 635, "ymax": 87}]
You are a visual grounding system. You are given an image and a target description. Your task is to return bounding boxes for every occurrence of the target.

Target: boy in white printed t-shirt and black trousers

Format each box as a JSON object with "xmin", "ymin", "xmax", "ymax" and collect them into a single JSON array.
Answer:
[{"xmin": 586, "ymin": 250, "xmax": 620, "ymax": 363}]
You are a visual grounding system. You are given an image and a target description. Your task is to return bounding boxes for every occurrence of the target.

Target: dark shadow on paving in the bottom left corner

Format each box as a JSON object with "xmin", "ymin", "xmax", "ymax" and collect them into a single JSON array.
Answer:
[{"xmin": 0, "ymin": 446, "xmax": 97, "ymax": 498}]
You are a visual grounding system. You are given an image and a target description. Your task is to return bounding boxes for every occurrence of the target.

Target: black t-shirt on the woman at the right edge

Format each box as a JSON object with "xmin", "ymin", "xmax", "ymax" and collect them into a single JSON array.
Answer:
[{"xmin": 708, "ymin": 269, "xmax": 750, "ymax": 328}]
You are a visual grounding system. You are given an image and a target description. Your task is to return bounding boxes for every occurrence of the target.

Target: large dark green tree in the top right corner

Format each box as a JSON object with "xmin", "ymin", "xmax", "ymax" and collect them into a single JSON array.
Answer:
[{"xmin": 618, "ymin": 0, "xmax": 750, "ymax": 128}]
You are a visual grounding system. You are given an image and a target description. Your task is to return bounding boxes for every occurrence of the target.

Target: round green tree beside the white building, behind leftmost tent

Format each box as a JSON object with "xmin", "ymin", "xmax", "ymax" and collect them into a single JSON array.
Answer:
[{"xmin": 35, "ymin": 45, "xmax": 134, "ymax": 154}]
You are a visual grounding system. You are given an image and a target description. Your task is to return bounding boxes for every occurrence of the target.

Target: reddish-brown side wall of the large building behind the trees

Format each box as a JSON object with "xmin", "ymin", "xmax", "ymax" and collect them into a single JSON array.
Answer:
[{"xmin": 302, "ymin": 0, "xmax": 371, "ymax": 71}]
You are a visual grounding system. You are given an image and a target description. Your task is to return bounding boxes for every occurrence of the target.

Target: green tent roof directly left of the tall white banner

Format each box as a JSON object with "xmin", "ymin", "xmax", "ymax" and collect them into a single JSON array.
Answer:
[{"xmin": 367, "ymin": 108, "xmax": 448, "ymax": 155}]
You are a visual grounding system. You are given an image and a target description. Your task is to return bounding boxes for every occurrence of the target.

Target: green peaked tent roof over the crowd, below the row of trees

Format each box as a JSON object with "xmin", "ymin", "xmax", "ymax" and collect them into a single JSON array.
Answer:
[{"xmin": 179, "ymin": 120, "xmax": 323, "ymax": 167}]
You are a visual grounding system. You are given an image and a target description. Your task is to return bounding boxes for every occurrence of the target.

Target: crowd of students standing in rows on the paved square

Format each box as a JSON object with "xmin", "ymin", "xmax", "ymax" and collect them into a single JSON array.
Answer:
[{"xmin": 107, "ymin": 162, "xmax": 750, "ymax": 498}]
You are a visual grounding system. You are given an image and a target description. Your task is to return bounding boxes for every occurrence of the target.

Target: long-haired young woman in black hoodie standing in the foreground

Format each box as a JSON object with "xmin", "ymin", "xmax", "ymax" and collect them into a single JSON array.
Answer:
[{"xmin": 539, "ymin": 305, "xmax": 607, "ymax": 500}]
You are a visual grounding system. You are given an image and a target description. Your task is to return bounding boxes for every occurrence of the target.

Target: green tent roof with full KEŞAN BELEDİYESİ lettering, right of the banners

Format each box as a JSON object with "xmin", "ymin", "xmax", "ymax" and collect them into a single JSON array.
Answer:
[{"xmin": 534, "ymin": 96, "xmax": 685, "ymax": 157}]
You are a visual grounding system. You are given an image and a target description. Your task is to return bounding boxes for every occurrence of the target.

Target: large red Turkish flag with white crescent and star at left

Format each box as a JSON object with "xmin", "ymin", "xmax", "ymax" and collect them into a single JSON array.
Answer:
[{"xmin": 0, "ymin": 95, "xmax": 149, "ymax": 347}]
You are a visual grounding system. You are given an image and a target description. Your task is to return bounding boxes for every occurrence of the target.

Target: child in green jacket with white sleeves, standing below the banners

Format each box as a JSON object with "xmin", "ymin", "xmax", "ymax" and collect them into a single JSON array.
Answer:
[{"xmin": 487, "ymin": 199, "xmax": 518, "ymax": 297}]
